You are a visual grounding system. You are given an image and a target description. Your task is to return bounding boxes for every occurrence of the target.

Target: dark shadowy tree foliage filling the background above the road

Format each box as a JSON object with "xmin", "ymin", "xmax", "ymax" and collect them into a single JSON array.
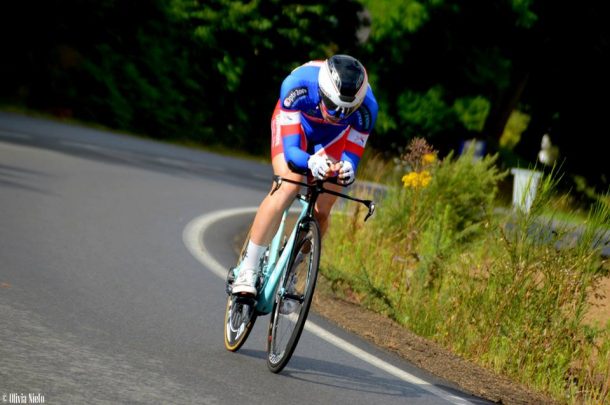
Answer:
[{"xmin": 0, "ymin": 0, "xmax": 610, "ymax": 191}]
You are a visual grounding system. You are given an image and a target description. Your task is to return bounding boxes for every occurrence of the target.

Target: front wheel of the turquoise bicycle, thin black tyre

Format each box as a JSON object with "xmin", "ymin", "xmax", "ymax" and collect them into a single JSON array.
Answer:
[{"xmin": 267, "ymin": 220, "xmax": 321, "ymax": 373}]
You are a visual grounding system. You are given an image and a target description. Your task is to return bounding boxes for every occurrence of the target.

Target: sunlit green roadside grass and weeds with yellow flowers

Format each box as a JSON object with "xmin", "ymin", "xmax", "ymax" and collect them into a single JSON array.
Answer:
[{"xmin": 322, "ymin": 140, "xmax": 610, "ymax": 404}]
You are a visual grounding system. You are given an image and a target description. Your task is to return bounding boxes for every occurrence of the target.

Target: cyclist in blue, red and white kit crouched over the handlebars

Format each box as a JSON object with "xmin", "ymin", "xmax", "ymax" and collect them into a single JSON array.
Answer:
[{"xmin": 232, "ymin": 55, "xmax": 377, "ymax": 295}]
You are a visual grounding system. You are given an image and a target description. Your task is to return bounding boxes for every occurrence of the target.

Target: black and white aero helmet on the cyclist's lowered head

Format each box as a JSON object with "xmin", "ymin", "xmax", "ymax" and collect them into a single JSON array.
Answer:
[{"xmin": 318, "ymin": 55, "xmax": 368, "ymax": 119}]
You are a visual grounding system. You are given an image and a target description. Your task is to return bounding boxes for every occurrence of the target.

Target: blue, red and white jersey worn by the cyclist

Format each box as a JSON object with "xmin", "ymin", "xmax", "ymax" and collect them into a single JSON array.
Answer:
[{"xmin": 271, "ymin": 61, "xmax": 378, "ymax": 170}]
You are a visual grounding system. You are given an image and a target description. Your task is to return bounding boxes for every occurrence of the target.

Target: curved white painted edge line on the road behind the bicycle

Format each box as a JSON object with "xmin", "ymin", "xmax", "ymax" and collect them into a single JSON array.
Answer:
[{"xmin": 182, "ymin": 207, "xmax": 472, "ymax": 405}]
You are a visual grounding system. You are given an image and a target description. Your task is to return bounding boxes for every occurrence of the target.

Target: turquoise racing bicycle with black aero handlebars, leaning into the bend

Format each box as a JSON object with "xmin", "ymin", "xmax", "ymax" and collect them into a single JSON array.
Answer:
[{"xmin": 224, "ymin": 171, "xmax": 375, "ymax": 373}]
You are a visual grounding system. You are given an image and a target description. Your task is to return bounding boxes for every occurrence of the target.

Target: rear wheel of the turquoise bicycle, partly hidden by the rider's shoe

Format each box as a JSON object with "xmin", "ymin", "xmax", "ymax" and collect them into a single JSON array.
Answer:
[{"xmin": 224, "ymin": 232, "xmax": 257, "ymax": 352}]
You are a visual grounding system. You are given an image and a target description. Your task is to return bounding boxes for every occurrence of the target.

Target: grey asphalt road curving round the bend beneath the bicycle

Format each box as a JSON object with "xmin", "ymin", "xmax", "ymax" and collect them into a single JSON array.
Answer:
[{"xmin": 0, "ymin": 113, "xmax": 484, "ymax": 404}]
